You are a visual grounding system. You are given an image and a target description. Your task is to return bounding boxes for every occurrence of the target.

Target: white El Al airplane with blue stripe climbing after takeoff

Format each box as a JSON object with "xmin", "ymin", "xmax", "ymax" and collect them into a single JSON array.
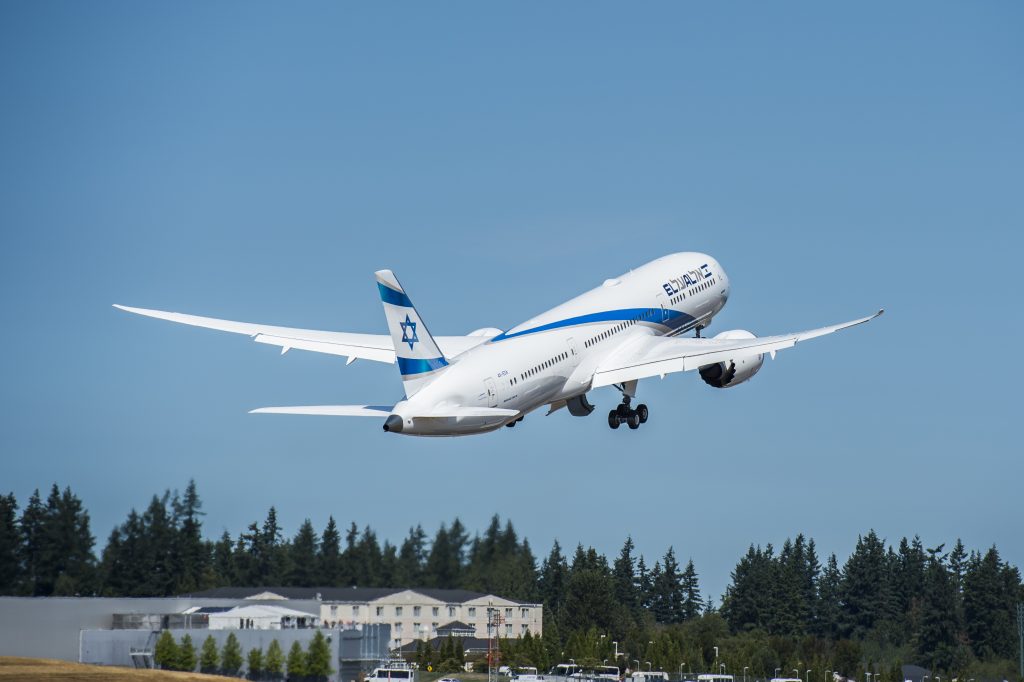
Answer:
[{"xmin": 115, "ymin": 252, "xmax": 884, "ymax": 436}]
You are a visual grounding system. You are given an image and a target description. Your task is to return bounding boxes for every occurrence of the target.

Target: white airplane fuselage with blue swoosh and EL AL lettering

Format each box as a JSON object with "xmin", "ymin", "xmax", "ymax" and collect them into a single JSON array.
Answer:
[{"xmin": 393, "ymin": 252, "xmax": 729, "ymax": 435}]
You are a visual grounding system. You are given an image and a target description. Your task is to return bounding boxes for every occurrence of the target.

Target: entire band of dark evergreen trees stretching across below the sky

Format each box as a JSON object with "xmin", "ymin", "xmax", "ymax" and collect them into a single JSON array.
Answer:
[{"xmin": 0, "ymin": 482, "xmax": 1024, "ymax": 682}]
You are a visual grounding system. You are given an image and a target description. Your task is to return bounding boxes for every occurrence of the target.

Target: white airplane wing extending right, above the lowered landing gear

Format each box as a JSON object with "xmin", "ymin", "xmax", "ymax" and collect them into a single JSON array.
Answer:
[{"xmin": 592, "ymin": 310, "xmax": 884, "ymax": 388}]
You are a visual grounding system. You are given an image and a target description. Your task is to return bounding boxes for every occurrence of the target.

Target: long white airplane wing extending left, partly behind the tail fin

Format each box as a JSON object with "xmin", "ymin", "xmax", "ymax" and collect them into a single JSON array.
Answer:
[{"xmin": 114, "ymin": 303, "xmax": 487, "ymax": 364}]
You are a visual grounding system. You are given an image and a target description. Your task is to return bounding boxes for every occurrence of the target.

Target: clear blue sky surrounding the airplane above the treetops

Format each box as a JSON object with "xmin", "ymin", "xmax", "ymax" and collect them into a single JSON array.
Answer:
[{"xmin": 0, "ymin": 2, "xmax": 1024, "ymax": 597}]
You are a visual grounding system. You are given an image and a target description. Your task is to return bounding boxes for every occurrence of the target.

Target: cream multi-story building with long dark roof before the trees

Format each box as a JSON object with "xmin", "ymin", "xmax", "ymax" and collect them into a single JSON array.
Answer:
[{"xmin": 195, "ymin": 587, "xmax": 544, "ymax": 648}]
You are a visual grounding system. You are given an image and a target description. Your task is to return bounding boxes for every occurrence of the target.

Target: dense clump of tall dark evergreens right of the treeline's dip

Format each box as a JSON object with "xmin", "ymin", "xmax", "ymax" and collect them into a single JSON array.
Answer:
[{"xmin": 721, "ymin": 530, "xmax": 1024, "ymax": 671}]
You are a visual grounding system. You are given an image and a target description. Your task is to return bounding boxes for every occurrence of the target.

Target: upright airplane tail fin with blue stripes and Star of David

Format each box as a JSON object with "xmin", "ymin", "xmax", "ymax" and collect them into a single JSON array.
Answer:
[{"xmin": 374, "ymin": 270, "xmax": 447, "ymax": 397}]
